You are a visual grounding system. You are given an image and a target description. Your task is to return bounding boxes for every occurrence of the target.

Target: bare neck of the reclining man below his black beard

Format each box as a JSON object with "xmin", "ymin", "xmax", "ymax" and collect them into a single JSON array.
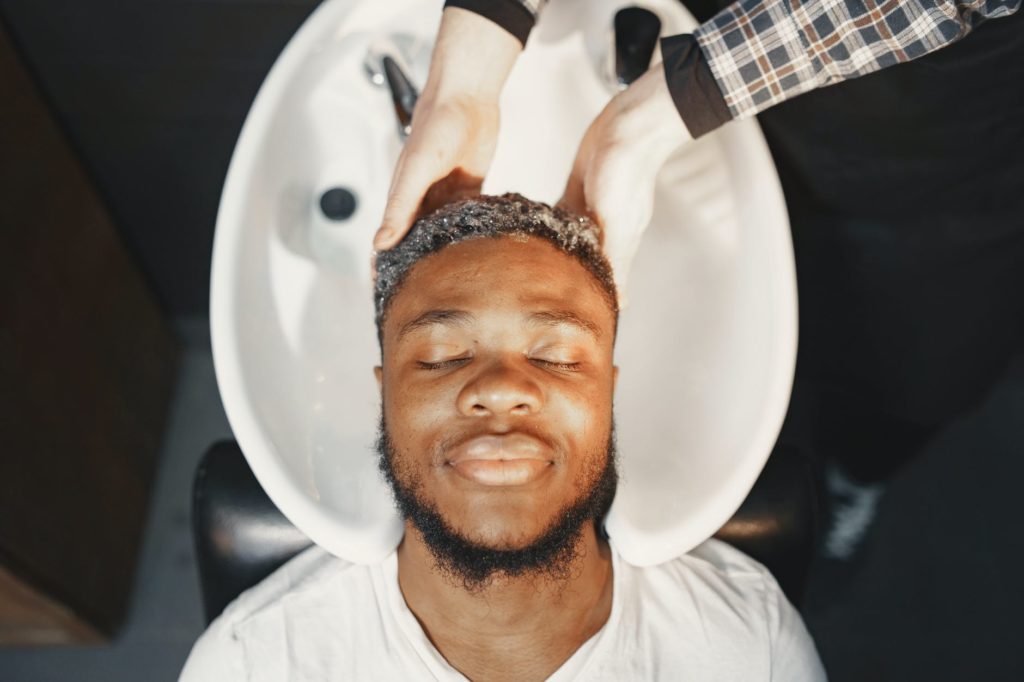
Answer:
[{"xmin": 398, "ymin": 523, "xmax": 611, "ymax": 680}]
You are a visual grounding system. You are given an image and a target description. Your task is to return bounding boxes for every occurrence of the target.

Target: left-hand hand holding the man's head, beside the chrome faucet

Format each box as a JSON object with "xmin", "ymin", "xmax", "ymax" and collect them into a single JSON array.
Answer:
[{"xmin": 374, "ymin": 7, "xmax": 522, "ymax": 251}]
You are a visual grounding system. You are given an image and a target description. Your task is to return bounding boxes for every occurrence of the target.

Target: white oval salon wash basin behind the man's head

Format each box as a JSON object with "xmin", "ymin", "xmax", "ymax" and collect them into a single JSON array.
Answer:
[{"xmin": 211, "ymin": 0, "xmax": 797, "ymax": 565}]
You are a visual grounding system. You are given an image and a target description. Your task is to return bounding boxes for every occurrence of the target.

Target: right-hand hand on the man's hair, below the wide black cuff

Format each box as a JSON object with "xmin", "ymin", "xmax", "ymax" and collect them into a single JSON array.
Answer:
[{"xmin": 559, "ymin": 63, "xmax": 691, "ymax": 305}]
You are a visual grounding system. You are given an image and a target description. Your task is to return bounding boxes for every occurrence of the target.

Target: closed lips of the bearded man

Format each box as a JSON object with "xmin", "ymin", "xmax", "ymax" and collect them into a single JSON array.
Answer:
[{"xmin": 444, "ymin": 433, "xmax": 554, "ymax": 486}]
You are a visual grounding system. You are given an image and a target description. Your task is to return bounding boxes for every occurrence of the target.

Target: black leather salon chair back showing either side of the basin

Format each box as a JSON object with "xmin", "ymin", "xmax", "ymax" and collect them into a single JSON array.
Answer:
[{"xmin": 193, "ymin": 440, "xmax": 818, "ymax": 623}]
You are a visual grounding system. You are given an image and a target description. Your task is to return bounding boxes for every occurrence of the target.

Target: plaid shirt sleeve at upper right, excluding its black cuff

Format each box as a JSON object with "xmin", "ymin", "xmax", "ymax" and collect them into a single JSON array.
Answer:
[{"xmin": 694, "ymin": 0, "xmax": 1021, "ymax": 118}]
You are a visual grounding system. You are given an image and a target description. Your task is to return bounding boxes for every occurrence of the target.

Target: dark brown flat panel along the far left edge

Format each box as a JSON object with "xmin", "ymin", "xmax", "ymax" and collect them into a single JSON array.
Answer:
[{"xmin": 0, "ymin": 17, "xmax": 176, "ymax": 641}]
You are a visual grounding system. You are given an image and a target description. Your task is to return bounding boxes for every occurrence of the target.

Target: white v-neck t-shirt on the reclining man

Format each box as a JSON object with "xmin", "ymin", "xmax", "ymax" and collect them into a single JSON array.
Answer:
[{"xmin": 180, "ymin": 540, "xmax": 825, "ymax": 682}]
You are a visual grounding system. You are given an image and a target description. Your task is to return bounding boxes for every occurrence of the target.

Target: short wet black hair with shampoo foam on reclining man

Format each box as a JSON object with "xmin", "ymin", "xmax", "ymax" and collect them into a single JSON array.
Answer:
[{"xmin": 374, "ymin": 194, "xmax": 618, "ymax": 346}]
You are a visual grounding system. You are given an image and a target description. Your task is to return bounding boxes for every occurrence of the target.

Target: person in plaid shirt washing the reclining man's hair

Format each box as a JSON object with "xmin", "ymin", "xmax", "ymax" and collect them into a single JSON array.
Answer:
[{"xmin": 375, "ymin": 0, "xmax": 1024, "ymax": 561}]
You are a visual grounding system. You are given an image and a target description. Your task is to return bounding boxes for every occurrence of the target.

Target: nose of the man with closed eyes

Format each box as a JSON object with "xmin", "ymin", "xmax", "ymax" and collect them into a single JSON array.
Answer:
[{"xmin": 458, "ymin": 359, "xmax": 544, "ymax": 417}]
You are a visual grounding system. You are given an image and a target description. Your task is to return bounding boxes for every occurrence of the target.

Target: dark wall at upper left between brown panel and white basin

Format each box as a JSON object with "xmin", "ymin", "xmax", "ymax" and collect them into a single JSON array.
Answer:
[{"xmin": 0, "ymin": 0, "xmax": 318, "ymax": 316}]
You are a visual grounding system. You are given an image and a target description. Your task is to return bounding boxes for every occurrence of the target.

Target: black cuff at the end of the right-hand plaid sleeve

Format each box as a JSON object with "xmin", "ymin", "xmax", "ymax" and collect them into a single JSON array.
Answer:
[{"xmin": 662, "ymin": 34, "xmax": 732, "ymax": 138}]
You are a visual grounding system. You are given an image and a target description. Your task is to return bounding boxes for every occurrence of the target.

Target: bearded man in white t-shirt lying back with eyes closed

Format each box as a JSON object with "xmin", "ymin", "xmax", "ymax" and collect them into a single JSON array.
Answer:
[{"xmin": 182, "ymin": 195, "xmax": 824, "ymax": 682}]
